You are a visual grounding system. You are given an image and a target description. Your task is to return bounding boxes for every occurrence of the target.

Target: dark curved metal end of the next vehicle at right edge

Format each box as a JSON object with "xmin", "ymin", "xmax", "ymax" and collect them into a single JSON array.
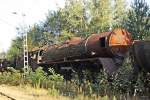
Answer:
[{"xmin": 132, "ymin": 41, "xmax": 150, "ymax": 72}]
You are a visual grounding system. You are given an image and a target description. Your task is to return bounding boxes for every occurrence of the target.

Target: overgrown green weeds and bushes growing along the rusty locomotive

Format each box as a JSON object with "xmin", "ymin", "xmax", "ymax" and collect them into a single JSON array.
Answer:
[{"xmin": 0, "ymin": 62, "xmax": 149, "ymax": 100}]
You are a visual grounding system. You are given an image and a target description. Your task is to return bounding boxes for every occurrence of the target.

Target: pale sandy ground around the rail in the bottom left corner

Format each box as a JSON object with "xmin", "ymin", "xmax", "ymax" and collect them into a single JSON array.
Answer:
[{"xmin": 0, "ymin": 85, "xmax": 69, "ymax": 100}]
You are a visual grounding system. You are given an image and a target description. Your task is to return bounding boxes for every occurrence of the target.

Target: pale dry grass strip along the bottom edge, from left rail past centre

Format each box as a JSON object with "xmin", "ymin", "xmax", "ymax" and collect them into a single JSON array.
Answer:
[{"xmin": 0, "ymin": 85, "xmax": 116, "ymax": 100}]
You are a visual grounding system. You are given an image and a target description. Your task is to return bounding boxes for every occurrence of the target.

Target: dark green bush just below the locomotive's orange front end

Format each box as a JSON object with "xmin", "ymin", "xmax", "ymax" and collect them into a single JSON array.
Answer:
[{"xmin": 106, "ymin": 58, "xmax": 133, "ymax": 94}]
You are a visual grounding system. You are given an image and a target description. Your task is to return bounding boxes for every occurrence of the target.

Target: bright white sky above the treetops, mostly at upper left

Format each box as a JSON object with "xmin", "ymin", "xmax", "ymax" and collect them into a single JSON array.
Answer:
[{"xmin": 0, "ymin": 0, "xmax": 150, "ymax": 52}]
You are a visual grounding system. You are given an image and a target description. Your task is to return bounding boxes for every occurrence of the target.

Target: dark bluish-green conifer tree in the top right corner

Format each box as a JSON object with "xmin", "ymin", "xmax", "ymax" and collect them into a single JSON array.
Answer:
[{"xmin": 125, "ymin": 0, "xmax": 150, "ymax": 39}]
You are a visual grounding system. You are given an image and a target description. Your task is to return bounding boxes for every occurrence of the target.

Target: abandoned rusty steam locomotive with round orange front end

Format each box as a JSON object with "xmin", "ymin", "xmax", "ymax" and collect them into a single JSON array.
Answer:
[{"xmin": 31, "ymin": 28, "xmax": 132, "ymax": 74}]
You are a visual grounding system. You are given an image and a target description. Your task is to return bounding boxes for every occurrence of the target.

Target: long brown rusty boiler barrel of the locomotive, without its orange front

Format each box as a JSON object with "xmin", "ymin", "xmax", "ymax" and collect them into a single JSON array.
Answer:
[{"xmin": 39, "ymin": 33, "xmax": 111, "ymax": 62}]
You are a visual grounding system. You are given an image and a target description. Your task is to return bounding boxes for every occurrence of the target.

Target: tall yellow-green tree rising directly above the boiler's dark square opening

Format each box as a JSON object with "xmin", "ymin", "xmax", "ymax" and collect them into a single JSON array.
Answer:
[{"xmin": 90, "ymin": 0, "xmax": 112, "ymax": 33}]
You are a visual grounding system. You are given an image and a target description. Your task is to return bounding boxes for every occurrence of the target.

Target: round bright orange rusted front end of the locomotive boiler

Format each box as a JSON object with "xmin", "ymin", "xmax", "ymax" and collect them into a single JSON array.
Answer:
[{"xmin": 108, "ymin": 29, "xmax": 133, "ymax": 54}]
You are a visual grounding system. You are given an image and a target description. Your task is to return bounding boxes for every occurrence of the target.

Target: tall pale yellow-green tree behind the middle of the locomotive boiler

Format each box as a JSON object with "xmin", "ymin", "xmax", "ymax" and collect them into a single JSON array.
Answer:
[{"xmin": 65, "ymin": 0, "xmax": 88, "ymax": 35}]
